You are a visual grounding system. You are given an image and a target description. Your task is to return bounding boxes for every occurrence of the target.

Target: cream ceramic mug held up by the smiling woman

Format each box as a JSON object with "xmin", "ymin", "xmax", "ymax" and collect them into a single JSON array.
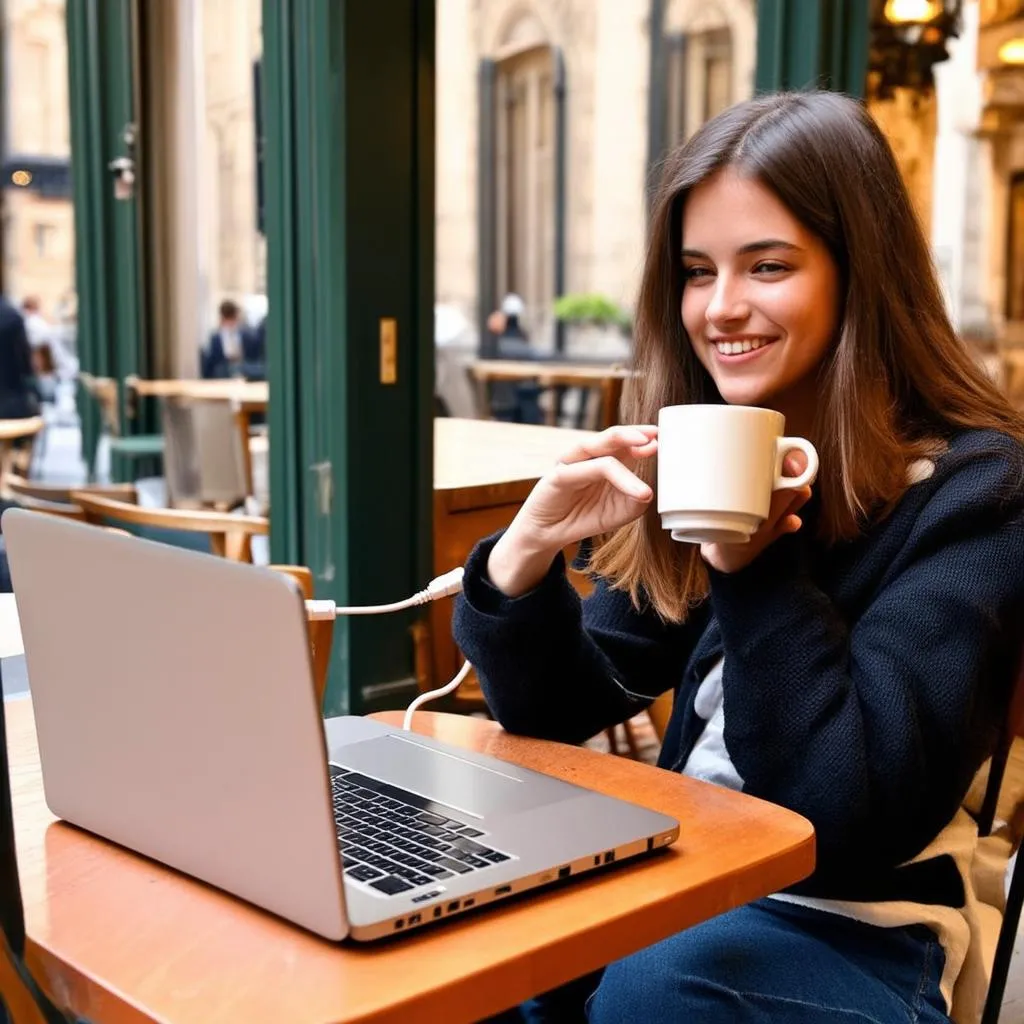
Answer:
[{"xmin": 657, "ymin": 406, "xmax": 818, "ymax": 544}]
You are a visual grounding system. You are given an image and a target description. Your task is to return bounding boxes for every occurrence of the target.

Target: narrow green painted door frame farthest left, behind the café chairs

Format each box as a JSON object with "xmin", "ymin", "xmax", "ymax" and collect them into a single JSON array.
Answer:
[{"xmin": 67, "ymin": 0, "xmax": 150, "ymax": 469}]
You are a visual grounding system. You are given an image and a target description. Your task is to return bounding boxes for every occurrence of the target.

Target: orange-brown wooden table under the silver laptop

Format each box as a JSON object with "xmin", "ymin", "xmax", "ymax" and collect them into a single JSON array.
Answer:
[{"xmin": 5, "ymin": 699, "xmax": 814, "ymax": 1024}]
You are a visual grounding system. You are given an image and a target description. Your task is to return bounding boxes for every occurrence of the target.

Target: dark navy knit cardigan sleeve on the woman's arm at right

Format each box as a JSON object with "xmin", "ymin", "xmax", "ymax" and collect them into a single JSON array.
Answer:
[{"xmin": 711, "ymin": 444, "xmax": 1024, "ymax": 880}]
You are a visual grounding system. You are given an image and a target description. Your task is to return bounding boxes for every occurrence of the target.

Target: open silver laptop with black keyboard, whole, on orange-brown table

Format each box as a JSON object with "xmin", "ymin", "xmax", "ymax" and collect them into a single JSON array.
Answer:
[{"xmin": 3, "ymin": 509, "xmax": 679, "ymax": 940}]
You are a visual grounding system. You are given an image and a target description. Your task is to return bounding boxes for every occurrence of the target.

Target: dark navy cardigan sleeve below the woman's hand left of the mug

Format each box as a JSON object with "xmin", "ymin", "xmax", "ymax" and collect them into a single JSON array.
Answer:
[{"xmin": 453, "ymin": 535, "xmax": 698, "ymax": 742}]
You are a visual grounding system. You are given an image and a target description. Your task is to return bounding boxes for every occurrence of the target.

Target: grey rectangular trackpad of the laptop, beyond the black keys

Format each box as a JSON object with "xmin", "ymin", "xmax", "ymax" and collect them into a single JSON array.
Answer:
[{"xmin": 332, "ymin": 735, "xmax": 567, "ymax": 817}]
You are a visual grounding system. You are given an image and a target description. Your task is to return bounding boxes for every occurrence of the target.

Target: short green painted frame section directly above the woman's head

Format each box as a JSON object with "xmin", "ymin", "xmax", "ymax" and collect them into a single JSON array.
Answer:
[{"xmin": 755, "ymin": 0, "xmax": 869, "ymax": 96}]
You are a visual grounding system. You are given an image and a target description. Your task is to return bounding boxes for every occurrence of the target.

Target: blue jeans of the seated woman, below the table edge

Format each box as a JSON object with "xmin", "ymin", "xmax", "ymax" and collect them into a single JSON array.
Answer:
[{"xmin": 505, "ymin": 899, "xmax": 949, "ymax": 1024}]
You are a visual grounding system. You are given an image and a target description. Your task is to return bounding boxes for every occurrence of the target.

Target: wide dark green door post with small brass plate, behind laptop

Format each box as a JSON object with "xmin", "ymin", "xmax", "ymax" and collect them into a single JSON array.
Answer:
[{"xmin": 262, "ymin": 0, "xmax": 434, "ymax": 714}]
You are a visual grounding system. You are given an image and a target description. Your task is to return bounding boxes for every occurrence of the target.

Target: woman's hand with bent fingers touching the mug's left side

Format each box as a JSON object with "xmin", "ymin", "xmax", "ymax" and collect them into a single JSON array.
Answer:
[{"xmin": 487, "ymin": 426, "xmax": 657, "ymax": 597}]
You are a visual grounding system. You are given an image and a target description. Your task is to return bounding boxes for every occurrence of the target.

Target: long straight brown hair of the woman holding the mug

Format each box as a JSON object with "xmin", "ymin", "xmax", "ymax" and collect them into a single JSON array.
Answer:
[{"xmin": 590, "ymin": 92, "xmax": 1024, "ymax": 622}]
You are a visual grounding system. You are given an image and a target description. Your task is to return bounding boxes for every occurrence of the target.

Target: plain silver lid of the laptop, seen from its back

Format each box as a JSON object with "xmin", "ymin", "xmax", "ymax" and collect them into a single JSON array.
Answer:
[{"xmin": 3, "ymin": 509, "xmax": 348, "ymax": 939}]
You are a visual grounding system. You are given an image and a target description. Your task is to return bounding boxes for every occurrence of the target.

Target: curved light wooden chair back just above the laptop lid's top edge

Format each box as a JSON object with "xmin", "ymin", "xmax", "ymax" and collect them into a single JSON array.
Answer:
[{"xmin": 71, "ymin": 489, "xmax": 270, "ymax": 562}]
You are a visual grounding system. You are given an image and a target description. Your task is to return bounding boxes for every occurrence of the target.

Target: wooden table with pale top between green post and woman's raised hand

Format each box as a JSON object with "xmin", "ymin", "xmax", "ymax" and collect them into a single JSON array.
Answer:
[{"xmin": 428, "ymin": 418, "xmax": 595, "ymax": 703}]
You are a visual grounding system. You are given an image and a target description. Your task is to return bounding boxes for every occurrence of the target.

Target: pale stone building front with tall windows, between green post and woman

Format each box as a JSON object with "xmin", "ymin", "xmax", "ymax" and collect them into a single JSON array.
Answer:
[{"xmin": 436, "ymin": 0, "xmax": 756, "ymax": 346}]
